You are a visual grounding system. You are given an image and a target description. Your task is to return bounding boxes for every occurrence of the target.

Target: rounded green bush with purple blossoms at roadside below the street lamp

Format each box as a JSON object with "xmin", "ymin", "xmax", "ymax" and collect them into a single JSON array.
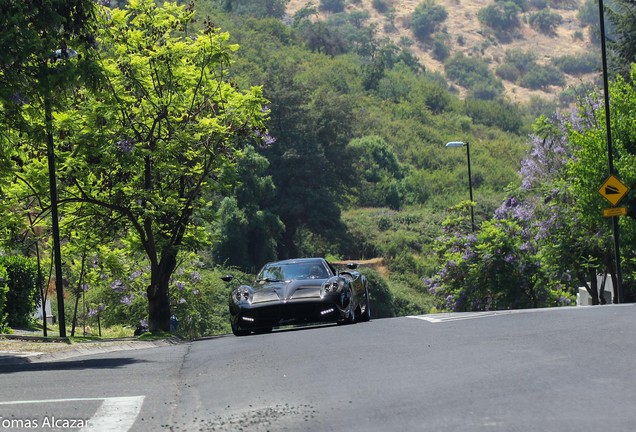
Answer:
[{"xmin": 425, "ymin": 212, "xmax": 574, "ymax": 312}]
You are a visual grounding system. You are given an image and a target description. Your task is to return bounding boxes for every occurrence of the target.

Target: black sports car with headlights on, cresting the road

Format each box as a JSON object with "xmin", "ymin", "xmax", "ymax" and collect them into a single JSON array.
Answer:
[{"xmin": 223, "ymin": 258, "xmax": 371, "ymax": 336}]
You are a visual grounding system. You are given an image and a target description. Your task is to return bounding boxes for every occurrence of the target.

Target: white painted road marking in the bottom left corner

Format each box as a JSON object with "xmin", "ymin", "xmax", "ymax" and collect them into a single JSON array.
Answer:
[{"xmin": 0, "ymin": 396, "xmax": 145, "ymax": 432}]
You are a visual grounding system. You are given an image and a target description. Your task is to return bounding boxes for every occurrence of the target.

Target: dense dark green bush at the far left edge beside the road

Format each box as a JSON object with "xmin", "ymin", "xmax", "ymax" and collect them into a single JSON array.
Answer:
[{"xmin": 0, "ymin": 256, "xmax": 40, "ymax": 327}]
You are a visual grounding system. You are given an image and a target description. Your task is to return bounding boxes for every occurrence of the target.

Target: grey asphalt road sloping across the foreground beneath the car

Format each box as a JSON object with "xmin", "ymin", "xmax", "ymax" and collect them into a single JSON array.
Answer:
[{"xmin": 0, "ymin": 305, "xmax": 636, "ymax": 432}]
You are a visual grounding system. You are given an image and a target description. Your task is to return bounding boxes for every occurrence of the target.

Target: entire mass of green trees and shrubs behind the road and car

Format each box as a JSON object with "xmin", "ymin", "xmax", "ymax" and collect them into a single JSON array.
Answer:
[{"xmin": 0, "ymin": 0, "xmax": 636, "ymax": 338}]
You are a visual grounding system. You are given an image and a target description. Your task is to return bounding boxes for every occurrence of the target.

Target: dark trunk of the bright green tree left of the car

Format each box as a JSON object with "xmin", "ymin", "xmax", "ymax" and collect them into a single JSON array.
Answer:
[{"xmin": 146, "ymin": 251, "xmax": 177, "ymax": 332}]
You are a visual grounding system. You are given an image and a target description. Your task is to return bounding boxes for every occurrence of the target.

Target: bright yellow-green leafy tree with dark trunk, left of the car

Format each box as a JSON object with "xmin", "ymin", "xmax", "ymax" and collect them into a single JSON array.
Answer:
[{"xmin": 50, "ymin": 0, "xmax": 267, "ymax": 331}]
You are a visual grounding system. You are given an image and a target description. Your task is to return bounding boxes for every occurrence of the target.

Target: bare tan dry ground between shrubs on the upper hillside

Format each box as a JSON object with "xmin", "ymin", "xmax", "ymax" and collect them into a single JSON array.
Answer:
[{"xmin": 287, "ymin": 0, "xmax": 597, "ymax": 102}]
